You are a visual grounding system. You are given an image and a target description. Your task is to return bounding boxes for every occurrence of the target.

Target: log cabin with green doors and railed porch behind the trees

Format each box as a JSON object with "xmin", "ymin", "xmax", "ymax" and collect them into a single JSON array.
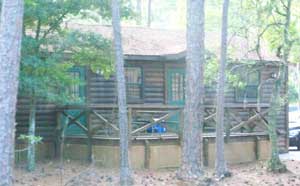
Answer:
[{"xmin": 16, "ymin": 24, "xmax": 288, "ymax": 169}]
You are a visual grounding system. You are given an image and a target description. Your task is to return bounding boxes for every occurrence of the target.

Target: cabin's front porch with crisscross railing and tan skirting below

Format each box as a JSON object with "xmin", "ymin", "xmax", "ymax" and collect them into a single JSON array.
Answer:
[{"xmin": 52, "ymin": 104, "xmax": 269, "ymax": 169}]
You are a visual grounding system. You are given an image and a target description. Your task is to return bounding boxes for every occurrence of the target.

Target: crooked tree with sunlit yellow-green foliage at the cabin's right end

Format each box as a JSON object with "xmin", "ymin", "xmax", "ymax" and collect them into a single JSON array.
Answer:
[{"xmin": 227, "ymin": 0, "xmax": 300, "ymax": 172}]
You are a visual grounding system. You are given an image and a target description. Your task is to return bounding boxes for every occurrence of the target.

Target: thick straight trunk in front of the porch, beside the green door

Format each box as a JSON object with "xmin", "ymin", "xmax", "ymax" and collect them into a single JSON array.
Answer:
[{"xmin": 178, "ymin": 0, "xmax": 205, "ymax": 181}]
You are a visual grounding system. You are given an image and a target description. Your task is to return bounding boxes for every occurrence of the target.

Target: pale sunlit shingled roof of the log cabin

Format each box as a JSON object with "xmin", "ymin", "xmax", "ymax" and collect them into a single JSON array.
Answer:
[{"xmin": 67, "ymin": 23, "xmax": 279, "ymax": 61}]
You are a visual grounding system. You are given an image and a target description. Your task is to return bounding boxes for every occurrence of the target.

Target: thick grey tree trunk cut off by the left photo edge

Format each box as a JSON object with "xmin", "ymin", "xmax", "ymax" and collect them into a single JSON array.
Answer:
[{"xmin": 0, "ymin": 0, "xmax": 24, "ymax": 186}]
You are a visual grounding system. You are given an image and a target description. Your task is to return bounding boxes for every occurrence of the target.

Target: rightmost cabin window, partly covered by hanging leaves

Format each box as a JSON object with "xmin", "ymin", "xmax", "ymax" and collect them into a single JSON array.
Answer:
[{"xmin": 235, "ymin": 71, "xmax": 260, "ymax": 102}]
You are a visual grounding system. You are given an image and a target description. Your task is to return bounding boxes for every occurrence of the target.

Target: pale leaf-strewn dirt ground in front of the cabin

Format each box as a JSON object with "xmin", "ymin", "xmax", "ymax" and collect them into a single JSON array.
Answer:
[{"xmin": 14, "ymin": 160, "xmax": 300, "ymax": 186}]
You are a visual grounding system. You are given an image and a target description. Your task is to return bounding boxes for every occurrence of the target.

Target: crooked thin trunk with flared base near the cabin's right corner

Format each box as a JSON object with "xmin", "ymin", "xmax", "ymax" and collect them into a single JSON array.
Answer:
[{"xmin": 268, "ymin": 0, "xmax": 292, "ymax": 172}]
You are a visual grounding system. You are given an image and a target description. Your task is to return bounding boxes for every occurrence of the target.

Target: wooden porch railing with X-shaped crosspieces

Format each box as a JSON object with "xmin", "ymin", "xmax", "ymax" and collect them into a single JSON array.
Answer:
[{"xmin": 57, "ymin": 104, "xmax": 269, "ymax": 138}]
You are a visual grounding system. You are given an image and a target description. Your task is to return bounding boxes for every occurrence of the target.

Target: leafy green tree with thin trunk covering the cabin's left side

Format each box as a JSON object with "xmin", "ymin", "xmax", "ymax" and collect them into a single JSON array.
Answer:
[{"xmin": 20, "ymin": 0, "xmax": 131, "ymax": 171}]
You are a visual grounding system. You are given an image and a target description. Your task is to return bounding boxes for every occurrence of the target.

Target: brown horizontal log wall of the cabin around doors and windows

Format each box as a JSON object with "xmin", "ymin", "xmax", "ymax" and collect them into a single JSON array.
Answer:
[{"xmin": 16, "ymin": 61, "xmax": 288, "ymax": 153}]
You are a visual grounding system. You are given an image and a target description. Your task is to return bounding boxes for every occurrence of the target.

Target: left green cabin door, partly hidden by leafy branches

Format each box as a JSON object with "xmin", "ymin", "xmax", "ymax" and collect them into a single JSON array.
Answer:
[{"xmin": 64, "ymin": 67, "xmax": 87, "ymax": 135}]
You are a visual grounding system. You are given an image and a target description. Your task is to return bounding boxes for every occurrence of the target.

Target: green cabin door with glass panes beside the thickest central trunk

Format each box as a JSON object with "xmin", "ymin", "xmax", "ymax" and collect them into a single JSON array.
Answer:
[{"xmin": 167, "ymin": 68, "xmax": 185, "ymax": 131}]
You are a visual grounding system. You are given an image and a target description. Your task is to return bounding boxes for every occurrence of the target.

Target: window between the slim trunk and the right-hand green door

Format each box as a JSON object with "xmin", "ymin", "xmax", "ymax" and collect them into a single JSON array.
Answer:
[{"xmin": 125, "ymin": 67, "xmax": 143, "ymax": 102}]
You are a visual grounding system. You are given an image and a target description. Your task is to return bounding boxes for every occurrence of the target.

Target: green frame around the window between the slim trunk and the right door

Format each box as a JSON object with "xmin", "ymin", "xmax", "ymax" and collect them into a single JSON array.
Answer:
[{"xmin": 124, "ymin": 65, "xmax": 145, "ymax": 104}]
